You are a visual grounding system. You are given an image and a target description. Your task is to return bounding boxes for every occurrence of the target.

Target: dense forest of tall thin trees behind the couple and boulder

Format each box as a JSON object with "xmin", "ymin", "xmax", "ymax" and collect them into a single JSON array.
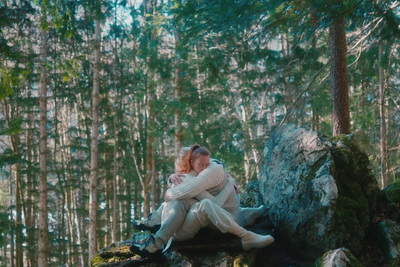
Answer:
[{"xmin": 0, "ymin": 0, "xmax": 400, "ymax": 266}]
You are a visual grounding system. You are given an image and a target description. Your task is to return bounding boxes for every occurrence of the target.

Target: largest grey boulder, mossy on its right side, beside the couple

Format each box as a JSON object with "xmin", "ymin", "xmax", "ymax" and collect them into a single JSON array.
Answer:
[{"xmin": 259, "ymin": 125, "xmax": 379, "ymax": 259}]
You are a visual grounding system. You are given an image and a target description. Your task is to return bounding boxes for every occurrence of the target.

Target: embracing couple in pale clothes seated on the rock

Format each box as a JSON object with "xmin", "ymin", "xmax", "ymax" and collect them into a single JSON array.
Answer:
[{"xmin": 130, "ymin": 145, "xmax": 274, "ymax": 257}]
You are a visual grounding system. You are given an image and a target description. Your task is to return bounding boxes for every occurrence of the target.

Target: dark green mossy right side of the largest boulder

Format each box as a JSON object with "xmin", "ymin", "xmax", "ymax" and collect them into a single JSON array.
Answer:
[{"xmin": 330, "ymin": 135, "xmax": 379, "ymax": 253}]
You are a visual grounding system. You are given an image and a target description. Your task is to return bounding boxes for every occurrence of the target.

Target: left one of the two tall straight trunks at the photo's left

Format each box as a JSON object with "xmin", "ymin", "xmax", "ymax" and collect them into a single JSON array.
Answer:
[{"xmin": 38, "ymin": 27, "xmax": 49, "ymax": 267}]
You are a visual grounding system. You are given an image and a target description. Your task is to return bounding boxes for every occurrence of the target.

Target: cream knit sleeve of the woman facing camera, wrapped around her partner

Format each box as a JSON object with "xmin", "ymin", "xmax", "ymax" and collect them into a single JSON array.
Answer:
[{"xmin": 165, "ymin": 162, "xmax": 226, "ymax": 200}]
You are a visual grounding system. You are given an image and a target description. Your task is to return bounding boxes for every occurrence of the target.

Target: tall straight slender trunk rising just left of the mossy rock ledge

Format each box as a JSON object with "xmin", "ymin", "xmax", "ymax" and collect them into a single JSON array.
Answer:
[{"xmin": 89, "ymin": 19, "xmax": 100, "ymax": 263}]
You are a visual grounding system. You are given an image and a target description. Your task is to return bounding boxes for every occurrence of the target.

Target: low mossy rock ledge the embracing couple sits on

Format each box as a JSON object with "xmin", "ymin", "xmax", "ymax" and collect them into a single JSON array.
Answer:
[{"xmin": 91, "ymin": 228, "xmax": 272, "ymax": 267}]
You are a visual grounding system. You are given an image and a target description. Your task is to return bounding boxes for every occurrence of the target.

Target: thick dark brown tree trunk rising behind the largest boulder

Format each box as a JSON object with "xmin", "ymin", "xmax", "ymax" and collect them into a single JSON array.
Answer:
[{"xmin": 329, "ymin": 12, "xmax": 350, "ymax": 135}]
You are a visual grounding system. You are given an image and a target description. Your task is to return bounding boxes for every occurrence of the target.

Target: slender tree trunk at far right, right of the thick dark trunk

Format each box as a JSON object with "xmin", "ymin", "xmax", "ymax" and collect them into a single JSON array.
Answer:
[{"xmin": 379, "ymin": 43, "xmax": 388, "ymax": 189}]
